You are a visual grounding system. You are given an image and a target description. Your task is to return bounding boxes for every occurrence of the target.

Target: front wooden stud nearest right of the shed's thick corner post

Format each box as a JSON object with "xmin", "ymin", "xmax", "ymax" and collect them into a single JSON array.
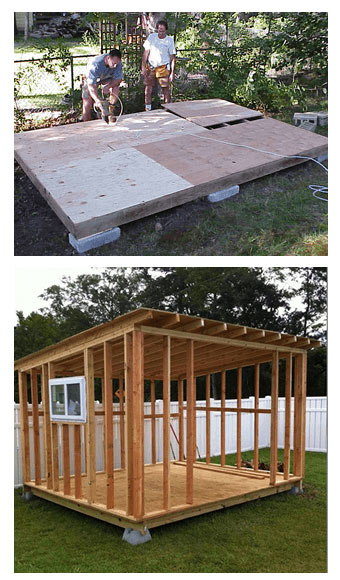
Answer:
[{"xmin": 163, "ymin": 336, "xmax": 171, "ymax": 510}]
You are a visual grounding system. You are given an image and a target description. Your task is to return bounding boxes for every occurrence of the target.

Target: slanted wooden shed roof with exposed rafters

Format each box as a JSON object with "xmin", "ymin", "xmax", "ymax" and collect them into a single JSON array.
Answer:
[{"xmin": 15, "ymin": 308, "xmax": 320, "ymax": 378}]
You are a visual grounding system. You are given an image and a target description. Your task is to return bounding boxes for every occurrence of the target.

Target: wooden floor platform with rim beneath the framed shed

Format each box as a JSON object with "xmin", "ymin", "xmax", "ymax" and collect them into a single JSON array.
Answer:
[{"xmin": 25, "ymin": 462, "xmax": 301, "ymax": 529}]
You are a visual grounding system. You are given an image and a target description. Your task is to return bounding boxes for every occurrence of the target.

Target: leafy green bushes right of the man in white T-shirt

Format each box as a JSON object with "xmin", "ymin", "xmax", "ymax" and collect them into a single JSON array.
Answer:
[{"xmin": 177, "ymin": 12, "xmax": 327, "ymax": 112}]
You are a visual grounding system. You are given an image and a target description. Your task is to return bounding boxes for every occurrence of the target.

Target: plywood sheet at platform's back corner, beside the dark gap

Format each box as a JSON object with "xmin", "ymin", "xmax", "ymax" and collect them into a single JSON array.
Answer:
[{"xmin": 163, "ymin": 99, "xmax": 262, "ymax": 127}]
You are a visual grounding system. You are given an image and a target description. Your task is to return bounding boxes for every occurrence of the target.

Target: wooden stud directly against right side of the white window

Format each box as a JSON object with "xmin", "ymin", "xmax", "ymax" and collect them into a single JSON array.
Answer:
[{"xmin": 84, "ymin": 348, "xmax": 96, "ymax": 504}]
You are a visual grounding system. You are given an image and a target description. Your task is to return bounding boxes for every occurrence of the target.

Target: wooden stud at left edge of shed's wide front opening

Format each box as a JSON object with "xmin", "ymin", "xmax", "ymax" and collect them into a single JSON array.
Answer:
[{"xmin": 186, "ymin": 340, "xmax": 195, "ymax": 504}]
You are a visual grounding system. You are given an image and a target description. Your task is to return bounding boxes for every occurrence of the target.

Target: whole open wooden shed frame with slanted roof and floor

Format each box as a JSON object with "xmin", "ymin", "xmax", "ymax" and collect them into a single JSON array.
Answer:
[{"xmin": 15, "ymin": 308, "xmax": 320, "ymax": 533}]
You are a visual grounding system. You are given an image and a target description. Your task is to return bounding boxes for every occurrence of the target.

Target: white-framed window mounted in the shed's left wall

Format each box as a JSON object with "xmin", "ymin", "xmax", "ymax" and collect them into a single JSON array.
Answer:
[{"xmin": 49, "ymin": 377, "xmax": 86, "ymax": 423}]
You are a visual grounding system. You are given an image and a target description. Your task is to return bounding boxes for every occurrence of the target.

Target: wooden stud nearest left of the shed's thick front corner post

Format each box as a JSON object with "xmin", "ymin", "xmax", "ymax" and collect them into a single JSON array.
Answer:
[{"xmin": 103, "ymin": 342, "xmax": 114, "ymax": 510}]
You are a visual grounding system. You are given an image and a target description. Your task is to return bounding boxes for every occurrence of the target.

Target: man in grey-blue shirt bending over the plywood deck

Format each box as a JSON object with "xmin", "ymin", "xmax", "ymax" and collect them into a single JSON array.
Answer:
[{"xmin": 82, "ymin": 48, "xmax": 123, "ymax": 122}]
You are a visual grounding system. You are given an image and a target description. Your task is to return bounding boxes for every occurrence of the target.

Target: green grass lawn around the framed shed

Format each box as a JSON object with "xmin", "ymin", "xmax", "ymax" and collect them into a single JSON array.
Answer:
[{"xmin": 15, "ymin": 450, "xmax": 327, "ymax": 573}]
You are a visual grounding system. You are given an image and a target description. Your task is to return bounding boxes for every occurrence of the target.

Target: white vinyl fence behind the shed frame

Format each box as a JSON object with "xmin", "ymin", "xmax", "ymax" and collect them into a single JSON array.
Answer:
[{"xmin": 14, "ymin": 396, "xmax": 327, "ymax": 487}]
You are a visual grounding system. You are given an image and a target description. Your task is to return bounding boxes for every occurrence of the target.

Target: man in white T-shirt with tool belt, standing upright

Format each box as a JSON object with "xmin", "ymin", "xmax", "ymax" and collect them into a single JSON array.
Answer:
[{"xmin": 142, "ymin": 20, "xmax": 176, "ymax": 111}]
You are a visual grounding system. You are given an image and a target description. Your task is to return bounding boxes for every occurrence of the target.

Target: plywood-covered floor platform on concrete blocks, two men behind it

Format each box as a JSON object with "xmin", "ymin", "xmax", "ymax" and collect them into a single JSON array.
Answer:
[{"xmin": 15, "ymin": 99, "xmax": 327, "ymax": 239}]
